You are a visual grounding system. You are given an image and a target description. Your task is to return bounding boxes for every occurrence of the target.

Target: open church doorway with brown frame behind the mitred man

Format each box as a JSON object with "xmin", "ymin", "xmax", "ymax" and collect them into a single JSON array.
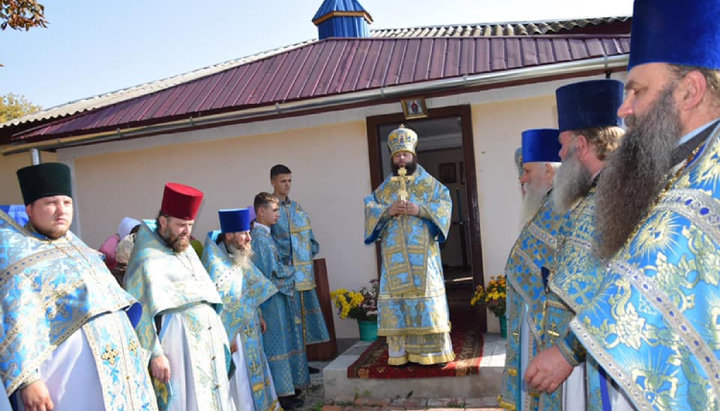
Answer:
[{"xmin": 367, "ymin": 106, "xmax": 486, "ymax": 331}]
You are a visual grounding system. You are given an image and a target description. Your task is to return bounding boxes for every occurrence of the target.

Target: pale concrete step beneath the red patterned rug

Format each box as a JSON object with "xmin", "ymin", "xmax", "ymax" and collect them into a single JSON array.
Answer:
[{"xmin": 323, "ymin": 334, "xmax": 505, "ymax": 406}]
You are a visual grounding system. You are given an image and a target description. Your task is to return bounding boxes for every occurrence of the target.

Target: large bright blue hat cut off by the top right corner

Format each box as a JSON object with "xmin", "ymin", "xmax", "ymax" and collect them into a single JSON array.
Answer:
[{"xmin": 628, "ymin": 0, "xmax": 720, "ymax": 70}]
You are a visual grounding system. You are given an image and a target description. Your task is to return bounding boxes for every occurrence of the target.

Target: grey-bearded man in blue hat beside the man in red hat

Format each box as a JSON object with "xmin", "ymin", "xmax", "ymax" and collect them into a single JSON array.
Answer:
[{"xmin": 202, "ymin": 208, "xmax": 280, "ymax": 411}]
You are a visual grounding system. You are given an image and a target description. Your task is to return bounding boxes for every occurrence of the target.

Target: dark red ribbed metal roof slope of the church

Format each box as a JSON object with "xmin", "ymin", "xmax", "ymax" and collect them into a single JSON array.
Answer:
[{"xmin": 12, "ymin": 35, "xmax": 630, "ymax": 145}]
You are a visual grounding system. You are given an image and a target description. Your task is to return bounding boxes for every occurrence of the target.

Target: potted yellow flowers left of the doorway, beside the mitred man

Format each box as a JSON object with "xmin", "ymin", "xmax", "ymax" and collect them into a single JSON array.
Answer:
[{"xmin": 330, "ymin": 280, "xmax": 380, "ymax": 341}]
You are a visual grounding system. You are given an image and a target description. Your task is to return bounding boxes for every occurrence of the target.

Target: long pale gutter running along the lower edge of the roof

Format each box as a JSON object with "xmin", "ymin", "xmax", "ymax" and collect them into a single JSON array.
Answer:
[{"xmin": 2, "ymin": 54, "xmax": 628, "ymax": 155}]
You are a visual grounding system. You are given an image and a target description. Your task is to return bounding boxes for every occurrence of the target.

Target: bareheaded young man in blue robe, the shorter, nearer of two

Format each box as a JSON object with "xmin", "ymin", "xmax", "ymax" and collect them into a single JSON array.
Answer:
[{"xmin": 251, "ymin": 192, "xmax": 310, "ymax": 409}]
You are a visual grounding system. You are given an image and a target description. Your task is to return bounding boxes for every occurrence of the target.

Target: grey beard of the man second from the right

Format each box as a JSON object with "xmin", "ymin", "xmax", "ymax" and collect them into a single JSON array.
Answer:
[{"xmin": 552, "ymin": 147, "xmax": 592, "ymax": 214}]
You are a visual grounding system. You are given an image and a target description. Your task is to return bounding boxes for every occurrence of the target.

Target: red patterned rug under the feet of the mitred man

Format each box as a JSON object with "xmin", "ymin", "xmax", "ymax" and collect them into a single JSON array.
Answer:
[{"xmin": 348, "ymin": 329, "xmax": 483, "ymax": 379}]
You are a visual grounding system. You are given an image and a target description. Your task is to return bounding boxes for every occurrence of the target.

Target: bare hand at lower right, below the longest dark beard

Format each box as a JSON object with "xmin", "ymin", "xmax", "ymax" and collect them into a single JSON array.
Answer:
[{"xmin": 525, "ymin": 346, "xmax": 573, "ymax": 393}]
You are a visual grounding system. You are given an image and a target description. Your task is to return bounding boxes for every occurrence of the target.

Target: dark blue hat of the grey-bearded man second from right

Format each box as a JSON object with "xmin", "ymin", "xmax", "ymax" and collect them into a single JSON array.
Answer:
[{"xmin": 555, "ymin": 79, "xmax": 623, "ymax": 133}]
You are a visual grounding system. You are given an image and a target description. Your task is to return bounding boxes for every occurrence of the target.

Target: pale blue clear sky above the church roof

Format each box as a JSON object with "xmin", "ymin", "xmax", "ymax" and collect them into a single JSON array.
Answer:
[{"xmin": 0, "ymin": 0, "xmax": 632, "ymax": 108}]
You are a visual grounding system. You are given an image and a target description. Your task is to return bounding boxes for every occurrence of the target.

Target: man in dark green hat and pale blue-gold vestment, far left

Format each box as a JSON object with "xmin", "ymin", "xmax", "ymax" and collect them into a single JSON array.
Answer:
[{"xmin": 0, "ymin": 163, "xmax": 157, "ymax": 411}]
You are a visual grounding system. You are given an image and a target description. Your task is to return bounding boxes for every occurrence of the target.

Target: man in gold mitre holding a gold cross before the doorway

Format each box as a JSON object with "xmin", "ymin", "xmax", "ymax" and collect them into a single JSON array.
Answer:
[{"xmin": 365, "ymin": 125, "xmax": 455, "ymax": 365}]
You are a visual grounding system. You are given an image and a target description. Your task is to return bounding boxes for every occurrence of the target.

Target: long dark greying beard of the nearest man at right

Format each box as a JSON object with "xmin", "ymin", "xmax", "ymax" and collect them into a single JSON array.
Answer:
[{"xmin": 596, "ymin": 83, "xmax": 682, "ymax": 258}]
